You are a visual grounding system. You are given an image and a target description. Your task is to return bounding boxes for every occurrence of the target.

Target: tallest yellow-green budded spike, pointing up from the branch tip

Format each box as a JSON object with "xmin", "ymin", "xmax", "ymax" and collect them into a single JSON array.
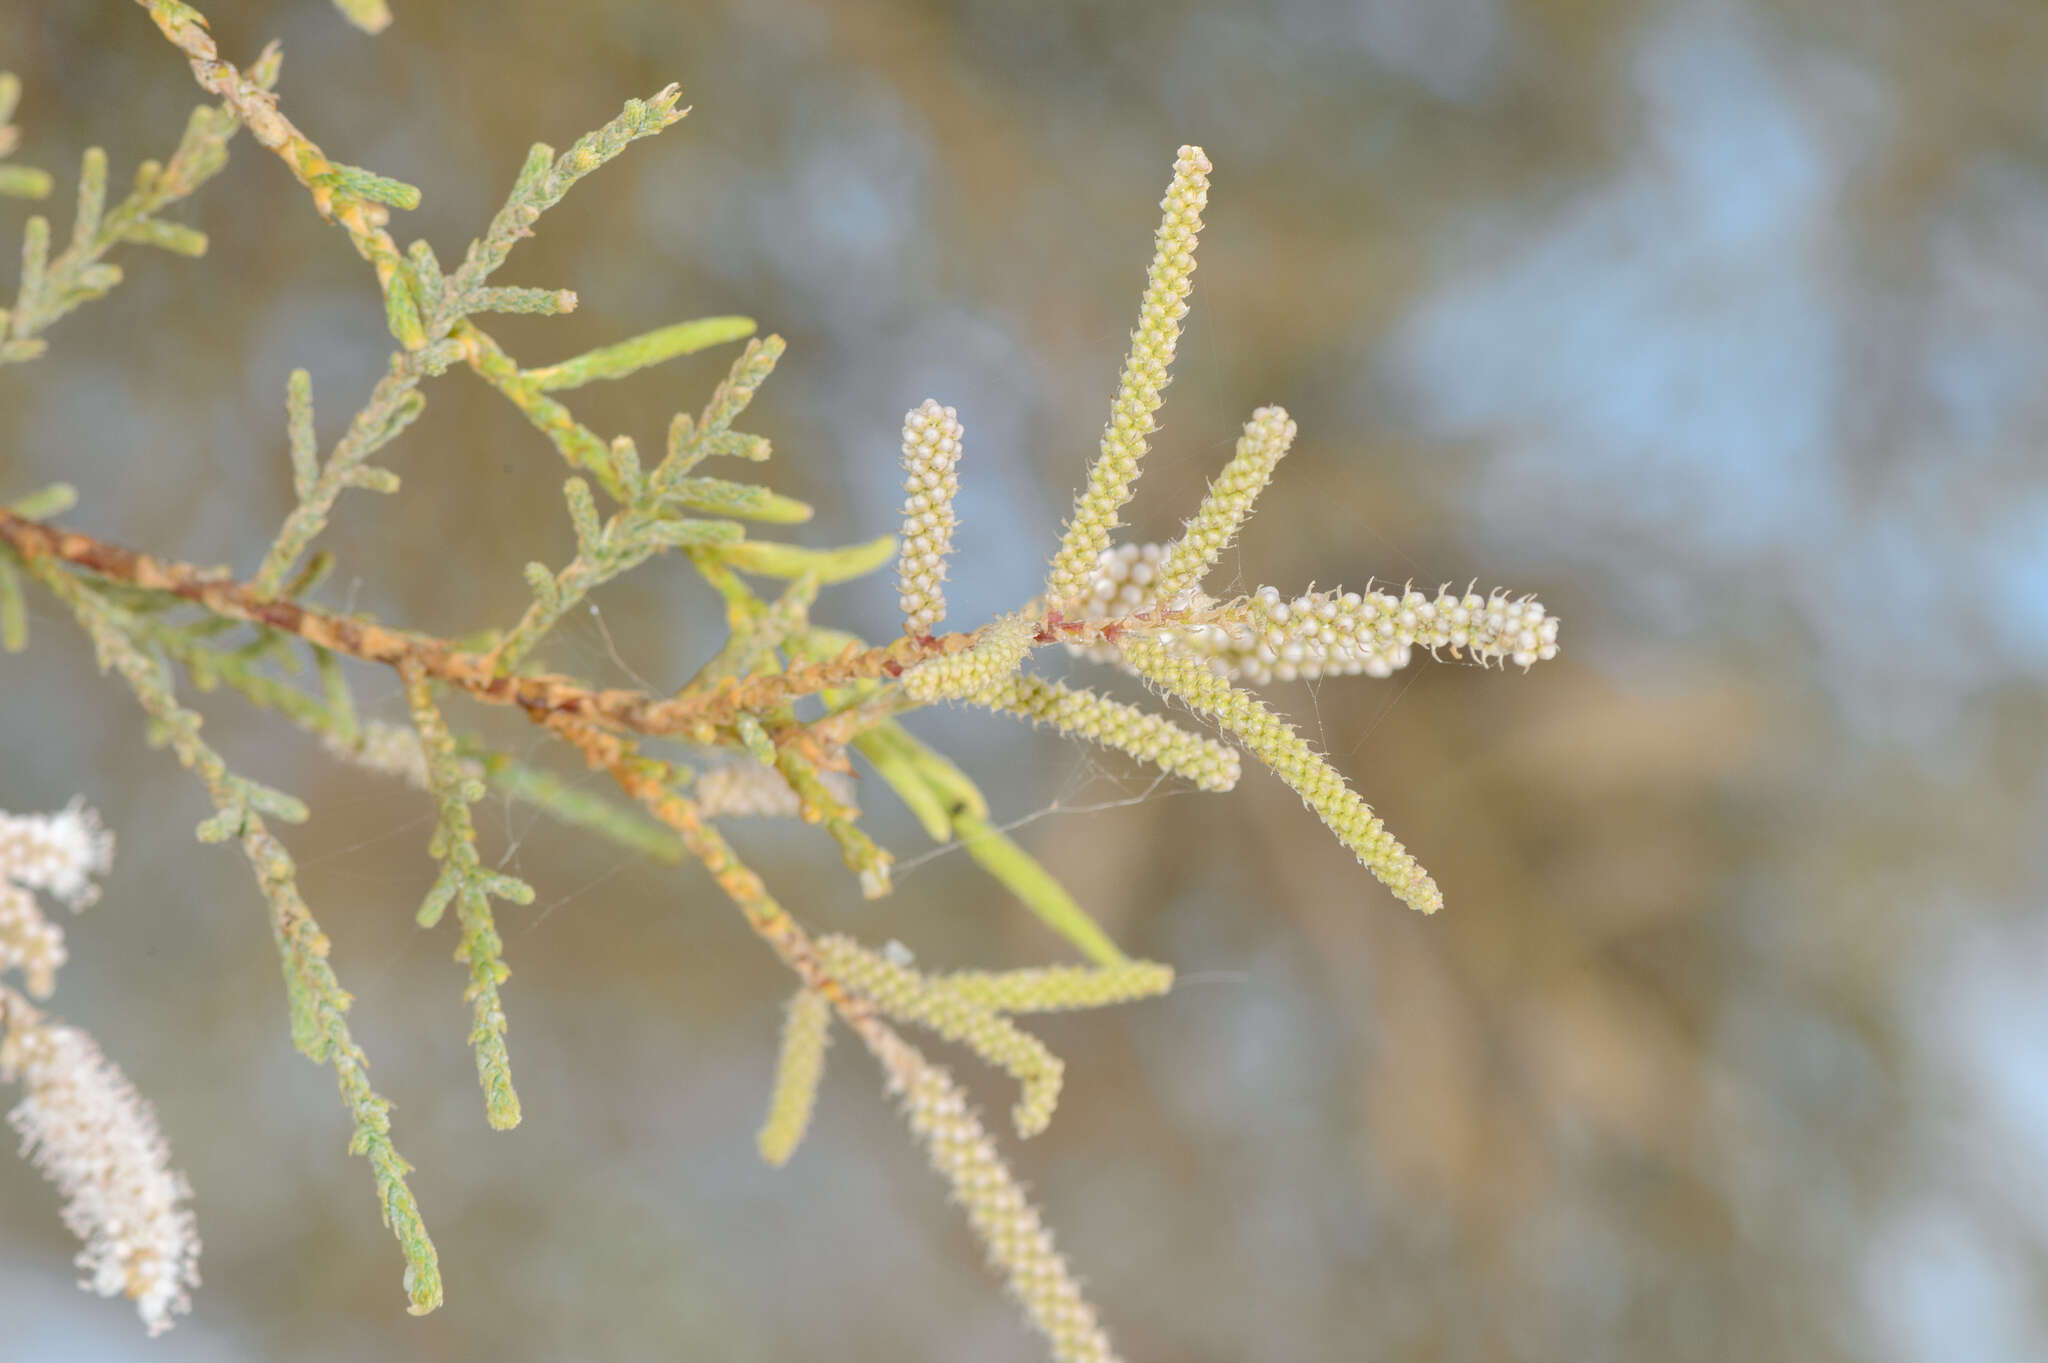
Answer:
[{"xmin": 1047, "ymin": 147, "xmax": 1214, "ymax": 608}]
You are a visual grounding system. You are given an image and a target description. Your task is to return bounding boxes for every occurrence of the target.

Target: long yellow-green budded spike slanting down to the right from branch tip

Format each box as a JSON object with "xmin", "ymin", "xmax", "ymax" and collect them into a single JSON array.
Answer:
[{"xmin": 1122, "ymin": 639, "xmax": 1444, "ymax": 913}]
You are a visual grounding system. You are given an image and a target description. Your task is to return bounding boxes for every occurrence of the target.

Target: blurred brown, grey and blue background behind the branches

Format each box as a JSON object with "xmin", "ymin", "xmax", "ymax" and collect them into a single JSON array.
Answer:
[{"xmin": 0, "ymin": 0, "xmax": 2048, "ymax": 1363}]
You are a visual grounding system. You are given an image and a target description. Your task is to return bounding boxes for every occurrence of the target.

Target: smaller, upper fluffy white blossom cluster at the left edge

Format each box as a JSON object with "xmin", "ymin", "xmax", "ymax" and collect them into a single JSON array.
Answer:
[{"xmin": 0, "ymin": 800, "xmax": 115, "ymax": 999}]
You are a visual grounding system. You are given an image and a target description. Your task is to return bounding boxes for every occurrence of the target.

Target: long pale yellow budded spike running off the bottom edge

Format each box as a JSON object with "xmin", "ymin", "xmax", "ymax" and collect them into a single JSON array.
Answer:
[{"xmin": 862, "ymin": 1027, "xmax": 1116, "ymax": 1363}]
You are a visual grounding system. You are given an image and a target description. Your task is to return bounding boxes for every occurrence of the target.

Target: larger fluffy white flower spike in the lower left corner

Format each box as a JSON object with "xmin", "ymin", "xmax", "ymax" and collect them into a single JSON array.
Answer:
[{"xmin": 0, "ymin": 997, "xmax": 199, "ymax": 1334}]
